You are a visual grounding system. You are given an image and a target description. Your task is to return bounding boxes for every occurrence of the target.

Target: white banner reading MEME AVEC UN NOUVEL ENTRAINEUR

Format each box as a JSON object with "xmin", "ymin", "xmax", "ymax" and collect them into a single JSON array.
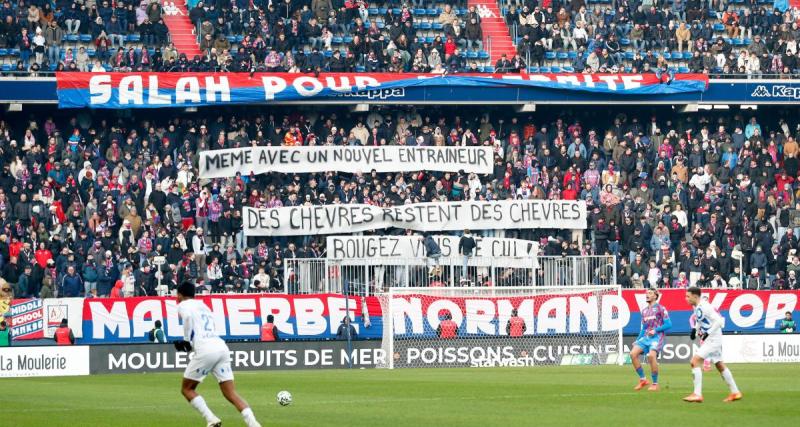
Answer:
[{"xmin": 200, "ymin": 145, "xmax": 494, "ymax": 179}]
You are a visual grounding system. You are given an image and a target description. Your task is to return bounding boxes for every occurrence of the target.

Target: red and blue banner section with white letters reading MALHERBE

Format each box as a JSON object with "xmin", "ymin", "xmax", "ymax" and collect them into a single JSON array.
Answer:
[{"xmin": 81, "ymin": 294, "xmax": 383, "ymax": 344}]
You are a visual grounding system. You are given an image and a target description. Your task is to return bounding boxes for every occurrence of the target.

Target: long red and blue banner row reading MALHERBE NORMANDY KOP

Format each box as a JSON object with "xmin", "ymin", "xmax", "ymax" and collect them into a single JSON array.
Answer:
[{"xmin": 5, "ymin": 289, "xmax": 800, "ymax": 344}]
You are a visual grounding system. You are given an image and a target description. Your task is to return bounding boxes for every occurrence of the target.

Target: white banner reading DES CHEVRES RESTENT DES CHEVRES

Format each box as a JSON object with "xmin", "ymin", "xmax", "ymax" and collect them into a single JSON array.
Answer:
[{"xmin": 242, "ymin": 200, "xmax": 586, "ymax": 236}]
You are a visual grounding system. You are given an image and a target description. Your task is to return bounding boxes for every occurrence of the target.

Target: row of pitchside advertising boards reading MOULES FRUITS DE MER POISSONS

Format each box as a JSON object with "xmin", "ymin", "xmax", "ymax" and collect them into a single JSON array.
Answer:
[{"xmin": 0, "ymin": 334, "xmax": 800, "ymax": 378}]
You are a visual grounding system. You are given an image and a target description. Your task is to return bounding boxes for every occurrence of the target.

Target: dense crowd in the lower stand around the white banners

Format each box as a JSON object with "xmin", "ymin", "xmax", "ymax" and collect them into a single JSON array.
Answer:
[{"xmin": 0, "ymin": 109, "xmax": 800, "ymax": 297}]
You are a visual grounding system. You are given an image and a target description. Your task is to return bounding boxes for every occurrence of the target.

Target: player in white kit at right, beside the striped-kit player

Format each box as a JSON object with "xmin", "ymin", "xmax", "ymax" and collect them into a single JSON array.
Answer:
[{"xmin": 683, "ymin": 286, "xmax": 742, "ymax": 403}]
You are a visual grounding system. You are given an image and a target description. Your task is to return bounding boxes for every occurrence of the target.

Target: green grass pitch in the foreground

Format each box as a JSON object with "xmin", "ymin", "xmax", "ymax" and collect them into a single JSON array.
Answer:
[{"xmin": 0, "ymin": 364, "xmax": 800, "ymax": 427}]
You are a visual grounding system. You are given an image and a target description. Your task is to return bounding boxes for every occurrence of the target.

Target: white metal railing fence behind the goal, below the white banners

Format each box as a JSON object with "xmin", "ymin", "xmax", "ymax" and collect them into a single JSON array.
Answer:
[{"xmin": 284, "ymin": 256, "xmax": 617, "ymax": 296}]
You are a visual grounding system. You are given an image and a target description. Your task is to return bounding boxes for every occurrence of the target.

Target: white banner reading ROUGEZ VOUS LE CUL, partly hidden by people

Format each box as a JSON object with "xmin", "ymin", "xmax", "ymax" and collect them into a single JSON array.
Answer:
[{"xmin": 325, "ymin": 236, "xmax": 539, "ymax": 267}]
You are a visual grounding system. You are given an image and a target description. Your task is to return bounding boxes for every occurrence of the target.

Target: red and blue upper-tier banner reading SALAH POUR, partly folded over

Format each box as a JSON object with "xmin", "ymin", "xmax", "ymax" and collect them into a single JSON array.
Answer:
[{"xmin": 56, "ymin": 73, "xmax": 708, "ymax": 109}]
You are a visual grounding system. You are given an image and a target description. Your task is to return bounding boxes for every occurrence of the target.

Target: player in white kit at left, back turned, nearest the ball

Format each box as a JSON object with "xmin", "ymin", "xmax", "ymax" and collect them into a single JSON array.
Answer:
[{"xmin": 174, "ymin": 282, "xmax": 261, "ymax": 427}]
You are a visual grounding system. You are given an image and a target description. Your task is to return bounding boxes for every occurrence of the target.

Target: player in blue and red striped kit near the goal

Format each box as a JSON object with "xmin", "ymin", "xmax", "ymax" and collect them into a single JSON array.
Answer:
[{"xmin": 631, "ymin": 288, "xmax": 672, "ymax": 391}]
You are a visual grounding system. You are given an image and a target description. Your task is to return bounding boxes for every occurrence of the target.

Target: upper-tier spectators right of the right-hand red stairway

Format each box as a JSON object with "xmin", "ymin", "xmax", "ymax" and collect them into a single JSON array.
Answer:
[{"xmin": 506, "ymin": 0, "xmax": 800, "ymax": 78}]
